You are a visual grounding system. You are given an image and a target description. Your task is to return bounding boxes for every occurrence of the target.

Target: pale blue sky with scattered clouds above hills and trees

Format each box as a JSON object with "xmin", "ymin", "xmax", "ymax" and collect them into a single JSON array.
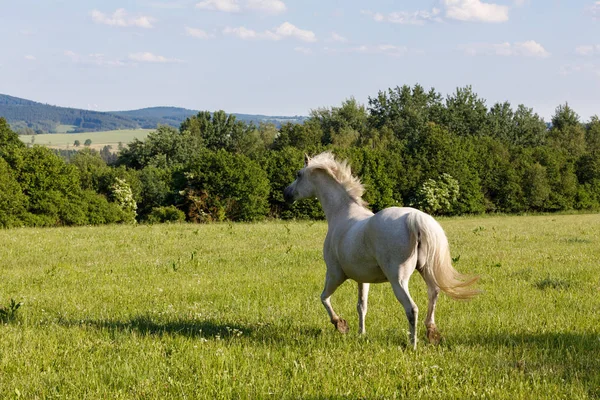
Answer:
[{"xmin": 0, "ymin": 0, "xmax": 600, "ymax": 120}]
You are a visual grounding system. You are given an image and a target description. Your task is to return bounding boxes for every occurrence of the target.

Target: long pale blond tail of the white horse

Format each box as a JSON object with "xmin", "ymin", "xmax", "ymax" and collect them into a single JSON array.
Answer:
[{"xmin": 406, "ymin": 210, "xmax": 480, "ymax": 299}]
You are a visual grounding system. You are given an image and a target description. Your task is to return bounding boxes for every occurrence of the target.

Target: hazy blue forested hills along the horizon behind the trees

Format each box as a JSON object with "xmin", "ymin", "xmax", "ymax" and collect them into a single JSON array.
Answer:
[{"xmin": 0, "ymin": 94, "xmax": 306, "ymax": 135}]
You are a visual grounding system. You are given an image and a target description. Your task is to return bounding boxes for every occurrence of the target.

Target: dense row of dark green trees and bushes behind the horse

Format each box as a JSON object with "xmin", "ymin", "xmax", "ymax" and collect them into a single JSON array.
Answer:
[{"xmin": 0, "ymin": 85, "xmax": 600, "ymax": 226}]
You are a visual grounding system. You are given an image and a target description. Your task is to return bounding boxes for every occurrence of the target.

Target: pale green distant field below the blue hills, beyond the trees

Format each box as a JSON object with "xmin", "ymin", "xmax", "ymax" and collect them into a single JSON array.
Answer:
[{"xmin": 19, "ymin": 130, "xmax": 154, "ymax": 149}]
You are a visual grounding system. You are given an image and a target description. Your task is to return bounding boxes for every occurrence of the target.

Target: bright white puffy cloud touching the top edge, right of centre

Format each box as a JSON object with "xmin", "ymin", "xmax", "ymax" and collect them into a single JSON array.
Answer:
[{"xmin": 442, "ymin": 0, "xmax": 508, "ymax": 22}]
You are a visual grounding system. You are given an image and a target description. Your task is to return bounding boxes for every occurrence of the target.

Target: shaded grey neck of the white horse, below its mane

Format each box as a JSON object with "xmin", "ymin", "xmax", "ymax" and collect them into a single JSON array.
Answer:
[{"xmin": 316, "ymin": 176, "xmax": 370, "ymax": 224}]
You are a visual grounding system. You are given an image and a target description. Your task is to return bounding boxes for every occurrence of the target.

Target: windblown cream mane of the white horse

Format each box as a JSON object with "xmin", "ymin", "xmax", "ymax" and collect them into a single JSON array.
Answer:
[{"xmin": 306, "ymin": 151, "xmax": 367, "ymax": 206}]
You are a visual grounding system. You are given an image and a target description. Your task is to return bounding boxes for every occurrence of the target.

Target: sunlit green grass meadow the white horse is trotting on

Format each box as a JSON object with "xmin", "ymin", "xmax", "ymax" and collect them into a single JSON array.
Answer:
[{"xmin": 0, "ymin": 214, "xmax": 600, "ymax": 399}]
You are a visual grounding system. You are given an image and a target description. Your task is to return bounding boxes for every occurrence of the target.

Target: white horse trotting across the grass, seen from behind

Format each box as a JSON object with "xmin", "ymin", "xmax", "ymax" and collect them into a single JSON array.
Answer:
[{"xmin": 284, "ymin": 152, "xmax": 479, "ymax": 349}]
